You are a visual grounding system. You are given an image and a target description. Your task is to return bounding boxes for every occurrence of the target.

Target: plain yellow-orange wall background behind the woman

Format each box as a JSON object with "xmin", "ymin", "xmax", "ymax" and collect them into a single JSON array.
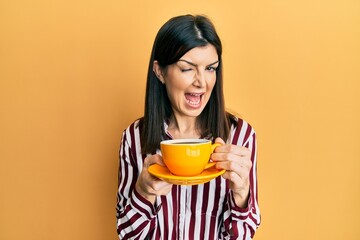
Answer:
[{"xmin": 0, "ymin": 0, "xmax": 360, "ymax": 240}]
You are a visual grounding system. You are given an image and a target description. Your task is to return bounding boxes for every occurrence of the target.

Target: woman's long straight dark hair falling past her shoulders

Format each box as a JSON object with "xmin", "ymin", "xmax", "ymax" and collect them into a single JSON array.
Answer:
[{"xmin": 140, "ymin": 15, "xmax": 233, "ymax": 154}]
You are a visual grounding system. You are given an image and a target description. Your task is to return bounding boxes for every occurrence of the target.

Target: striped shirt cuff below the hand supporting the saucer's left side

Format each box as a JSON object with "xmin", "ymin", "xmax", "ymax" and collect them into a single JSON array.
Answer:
[{"xmin": 130, "ymin": 188, "xmax": 161, "ymax": 220}]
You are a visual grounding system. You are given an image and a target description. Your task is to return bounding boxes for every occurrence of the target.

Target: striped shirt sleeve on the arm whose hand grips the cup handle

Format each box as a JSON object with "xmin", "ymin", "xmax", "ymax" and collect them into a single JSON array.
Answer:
[{"xmin": 222, "ymin": 123, "xmax": 260, "ymax": 240}]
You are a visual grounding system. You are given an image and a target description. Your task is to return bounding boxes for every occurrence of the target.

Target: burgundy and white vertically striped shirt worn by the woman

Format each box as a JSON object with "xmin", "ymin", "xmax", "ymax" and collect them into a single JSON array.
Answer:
[{"xmin": 116, "ymin": 119, "xmax": 260, "ymax": 240}]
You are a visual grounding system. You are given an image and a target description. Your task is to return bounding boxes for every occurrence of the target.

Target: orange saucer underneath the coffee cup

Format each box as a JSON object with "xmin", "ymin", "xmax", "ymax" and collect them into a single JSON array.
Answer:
[{"xmin": 148, "ymin": 164, "xmax": 225, "ymax": 185}]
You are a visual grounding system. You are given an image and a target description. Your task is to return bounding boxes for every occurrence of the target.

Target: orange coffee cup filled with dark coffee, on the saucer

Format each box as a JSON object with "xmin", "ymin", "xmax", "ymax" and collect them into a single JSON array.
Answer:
[{"xmin": 160, "ymin": 139, "xmax": 221, "ymax": 176}]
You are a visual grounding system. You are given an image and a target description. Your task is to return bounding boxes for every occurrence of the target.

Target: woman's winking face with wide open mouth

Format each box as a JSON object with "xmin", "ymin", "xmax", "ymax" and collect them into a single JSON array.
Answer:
[{"xmin": 155, "ymin": 44, "xmax": 219, "ymax": 118}]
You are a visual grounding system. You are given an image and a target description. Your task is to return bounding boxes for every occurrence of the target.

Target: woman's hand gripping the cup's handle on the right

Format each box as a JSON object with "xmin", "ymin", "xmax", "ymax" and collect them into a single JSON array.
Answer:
[{"xmin": 211, "ymin": 138, "xmax": 252, "ymax": 208}]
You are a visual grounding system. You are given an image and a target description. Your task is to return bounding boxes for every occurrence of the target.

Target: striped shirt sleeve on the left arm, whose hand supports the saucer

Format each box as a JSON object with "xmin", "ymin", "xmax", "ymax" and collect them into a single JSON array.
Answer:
[{"xmin": 116, "ymin": 126, "xmax": 160, "ymax": 239}]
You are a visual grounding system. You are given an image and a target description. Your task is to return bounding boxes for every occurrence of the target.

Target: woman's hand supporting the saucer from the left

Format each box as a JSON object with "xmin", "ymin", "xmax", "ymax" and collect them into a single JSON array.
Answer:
[{"xmin": 135, "ymin": 154, "xmax": 172, "ymax": 203}]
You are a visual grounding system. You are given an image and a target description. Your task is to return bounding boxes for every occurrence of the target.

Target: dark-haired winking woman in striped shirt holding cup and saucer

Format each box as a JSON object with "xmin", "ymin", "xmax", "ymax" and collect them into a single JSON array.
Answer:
[{"xmin": 117, "ymin": 15, "xmax": 260, "ymax": 239}]
